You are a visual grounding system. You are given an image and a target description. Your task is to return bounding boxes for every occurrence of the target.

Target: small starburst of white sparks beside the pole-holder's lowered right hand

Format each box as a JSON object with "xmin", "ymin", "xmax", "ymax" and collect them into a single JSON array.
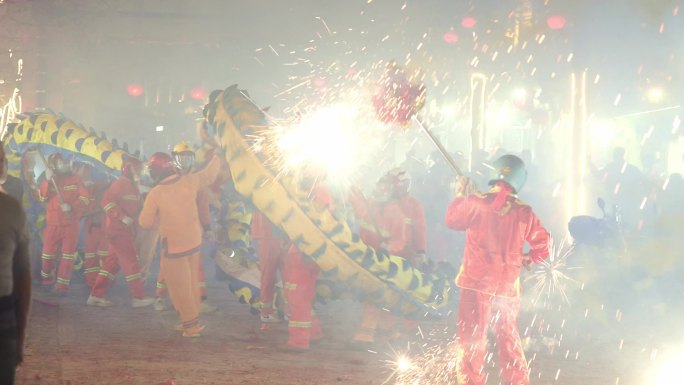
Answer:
[{"xmin": 525, "ymin": 239, "xmax": 581, "ymax": 304}]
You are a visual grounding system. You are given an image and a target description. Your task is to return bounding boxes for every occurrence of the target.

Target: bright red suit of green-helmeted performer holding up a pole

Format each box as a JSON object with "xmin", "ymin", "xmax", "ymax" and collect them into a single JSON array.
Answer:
[{"xmin": 446, "ymin": 190, "xmax": 549, "ymax": 385}]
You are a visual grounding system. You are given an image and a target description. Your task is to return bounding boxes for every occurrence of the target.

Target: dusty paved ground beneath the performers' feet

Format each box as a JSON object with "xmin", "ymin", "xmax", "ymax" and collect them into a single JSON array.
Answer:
[{"xmin": 12, "ymin": 274, "xmax": 682, "ymax": 385}]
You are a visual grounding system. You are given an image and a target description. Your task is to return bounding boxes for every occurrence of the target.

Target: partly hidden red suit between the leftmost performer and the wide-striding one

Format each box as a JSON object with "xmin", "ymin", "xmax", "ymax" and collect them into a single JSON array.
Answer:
[{"xmin": 83, "ymin": 182, "xmax": 109, "ymax": 288}]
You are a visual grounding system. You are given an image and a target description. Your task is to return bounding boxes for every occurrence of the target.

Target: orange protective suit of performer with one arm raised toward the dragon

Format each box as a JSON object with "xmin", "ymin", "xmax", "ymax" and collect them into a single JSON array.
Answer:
[{"xmin": 139, "ymin": 156, "xmax": 221, "ymax": 333}]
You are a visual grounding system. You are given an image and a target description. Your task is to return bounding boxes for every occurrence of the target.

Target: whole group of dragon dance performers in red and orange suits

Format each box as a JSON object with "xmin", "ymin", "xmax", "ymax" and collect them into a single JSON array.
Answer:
[{"xmin": 2, "ymin": 128, "xmax": 549, "ymax": 384}]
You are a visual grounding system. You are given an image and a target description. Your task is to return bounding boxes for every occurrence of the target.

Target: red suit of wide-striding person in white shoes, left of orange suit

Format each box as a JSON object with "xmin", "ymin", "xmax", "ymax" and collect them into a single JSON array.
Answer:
[{"xmin": 91, "ymin": 176, "xmax": 146, "ymax": 299}]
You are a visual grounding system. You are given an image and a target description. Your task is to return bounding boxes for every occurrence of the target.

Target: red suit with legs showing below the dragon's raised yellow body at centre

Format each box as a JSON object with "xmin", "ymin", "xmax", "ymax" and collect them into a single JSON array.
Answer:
[{"xmin": 283, "ymin": 187, "xmax": 332, "ymax": 349}]
